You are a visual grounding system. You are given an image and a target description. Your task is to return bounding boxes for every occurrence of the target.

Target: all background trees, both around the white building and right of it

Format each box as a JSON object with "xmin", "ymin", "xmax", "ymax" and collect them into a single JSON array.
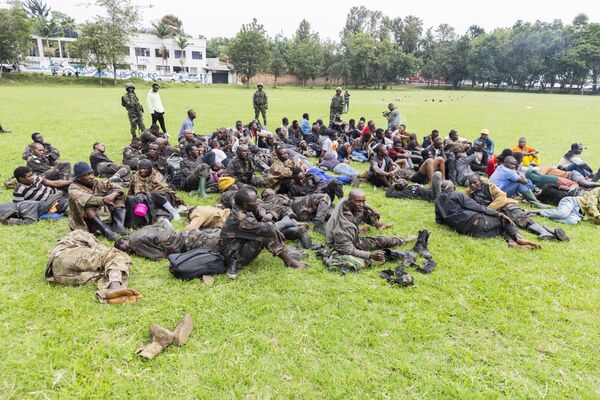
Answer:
[{"xmin": 0, "ymin": 0, "xmax": 600, "ymax": 93}]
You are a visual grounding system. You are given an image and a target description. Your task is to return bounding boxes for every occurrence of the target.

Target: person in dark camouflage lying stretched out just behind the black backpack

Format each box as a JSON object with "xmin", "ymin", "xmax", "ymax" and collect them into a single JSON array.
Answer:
[{"xmin": 115, "ymin": 218, "xmax": 221, "ymax": 260}]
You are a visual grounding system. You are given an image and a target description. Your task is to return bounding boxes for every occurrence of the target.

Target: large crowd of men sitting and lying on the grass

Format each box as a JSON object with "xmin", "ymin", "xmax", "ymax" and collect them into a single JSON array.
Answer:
[{"xmin": 0, "ymin": 94, "xmax": 600, "ymax": 303}]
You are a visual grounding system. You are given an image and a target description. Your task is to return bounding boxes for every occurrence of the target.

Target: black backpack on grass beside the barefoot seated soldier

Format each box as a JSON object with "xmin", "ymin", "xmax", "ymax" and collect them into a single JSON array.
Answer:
[{"xmin": 167, "ymin": 249, "xmax": 226, "ymax": 281}]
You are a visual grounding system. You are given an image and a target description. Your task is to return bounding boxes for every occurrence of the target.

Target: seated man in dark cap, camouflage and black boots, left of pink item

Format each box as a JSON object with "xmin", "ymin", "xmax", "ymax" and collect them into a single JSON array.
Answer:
[{"xmin": 69, "ymin": 161, "xmax": 127, "ymax": 240}]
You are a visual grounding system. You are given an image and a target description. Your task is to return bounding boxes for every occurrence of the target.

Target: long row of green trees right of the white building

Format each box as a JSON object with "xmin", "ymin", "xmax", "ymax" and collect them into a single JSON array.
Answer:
[{"xmin": 218, "ymin": 6, "xmax": 600, "ymax": 93}]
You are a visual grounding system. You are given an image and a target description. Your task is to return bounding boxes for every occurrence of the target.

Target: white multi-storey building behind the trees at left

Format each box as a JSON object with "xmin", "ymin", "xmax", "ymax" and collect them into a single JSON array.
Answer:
[{"xmin": 22, "ymin": 33, "xmax": 235, "ymax": 83}]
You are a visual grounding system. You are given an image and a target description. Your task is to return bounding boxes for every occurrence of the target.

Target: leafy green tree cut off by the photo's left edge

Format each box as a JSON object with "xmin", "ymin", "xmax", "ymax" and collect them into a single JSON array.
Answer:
[{"xmin": 0, "ymin": 7, "xmax": 32, "ymax": 75}]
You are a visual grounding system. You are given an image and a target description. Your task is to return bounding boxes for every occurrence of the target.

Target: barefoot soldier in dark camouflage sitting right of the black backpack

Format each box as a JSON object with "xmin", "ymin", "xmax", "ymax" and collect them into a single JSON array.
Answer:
[{"xmin": 218, "ymin": 189, "xmax": 308, "ymax": 279}]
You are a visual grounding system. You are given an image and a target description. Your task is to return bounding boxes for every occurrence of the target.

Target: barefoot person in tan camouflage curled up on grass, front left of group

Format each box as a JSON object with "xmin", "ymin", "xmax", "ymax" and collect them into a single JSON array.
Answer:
[{"xmin": 44, "ymin": 229, "xmax": 141, "ymax": 304}]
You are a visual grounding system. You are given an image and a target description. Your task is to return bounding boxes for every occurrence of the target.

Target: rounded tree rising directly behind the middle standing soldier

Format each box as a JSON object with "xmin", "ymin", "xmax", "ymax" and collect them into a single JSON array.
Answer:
[{"xmin": 227, "ymin": 18, "xmax": 269, "ymax": 85}]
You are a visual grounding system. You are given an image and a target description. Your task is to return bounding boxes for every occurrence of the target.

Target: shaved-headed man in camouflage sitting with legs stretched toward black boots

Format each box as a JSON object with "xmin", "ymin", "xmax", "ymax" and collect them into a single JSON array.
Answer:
[{"xmin": 325, "ymin": 189, "xmax": 416, "ymax": 266}]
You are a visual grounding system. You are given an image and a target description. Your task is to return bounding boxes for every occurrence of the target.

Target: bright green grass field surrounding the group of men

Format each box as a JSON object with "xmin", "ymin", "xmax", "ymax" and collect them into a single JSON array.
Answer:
[{"xmin": 0, "ymin": 85, "xmax": 600, "ymax": 399}]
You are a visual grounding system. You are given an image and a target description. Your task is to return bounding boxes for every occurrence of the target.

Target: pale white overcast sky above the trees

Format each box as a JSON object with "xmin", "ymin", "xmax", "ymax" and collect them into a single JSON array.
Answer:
[{"xmin": 16, "ymin": 0, "xmax": 600, "ymax": 40}]
